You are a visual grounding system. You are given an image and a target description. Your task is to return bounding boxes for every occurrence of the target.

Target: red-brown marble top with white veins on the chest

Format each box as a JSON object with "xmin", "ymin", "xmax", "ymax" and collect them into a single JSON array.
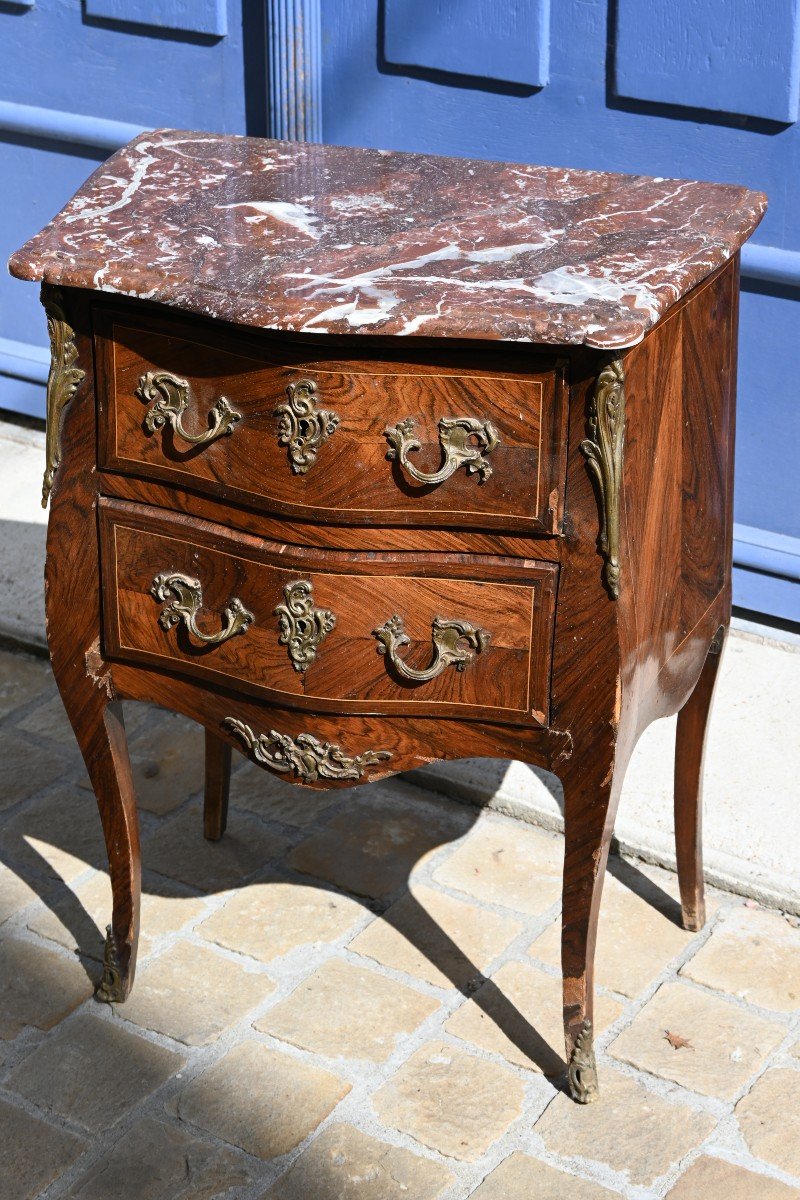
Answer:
[{"xmin": 8, "ymin": 130, "xmax": 766, "ymax": 349}]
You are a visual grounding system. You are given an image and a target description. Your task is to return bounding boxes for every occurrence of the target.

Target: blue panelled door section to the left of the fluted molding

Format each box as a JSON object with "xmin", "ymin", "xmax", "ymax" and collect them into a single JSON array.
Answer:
[{"xmin": 0, "ymin": 0, "xmax": 266, "ymax": 415}]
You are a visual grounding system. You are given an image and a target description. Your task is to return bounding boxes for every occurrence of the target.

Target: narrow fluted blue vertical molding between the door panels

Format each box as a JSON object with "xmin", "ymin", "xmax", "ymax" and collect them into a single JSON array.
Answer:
[{"xmin": 266, "ymin": 0, "xmax": 323, "ymax": 142}]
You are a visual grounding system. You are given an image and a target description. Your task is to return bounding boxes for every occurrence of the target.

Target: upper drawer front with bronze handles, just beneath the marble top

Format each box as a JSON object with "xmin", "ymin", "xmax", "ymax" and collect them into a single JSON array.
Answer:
[{"xmin": 95, "ymin": 310, "xmax": 566, "ymax": 534}]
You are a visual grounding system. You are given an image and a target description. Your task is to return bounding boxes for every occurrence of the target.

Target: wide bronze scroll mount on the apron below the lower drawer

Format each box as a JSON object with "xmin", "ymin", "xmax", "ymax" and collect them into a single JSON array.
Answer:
[{"xmin": 222, "ymin": 716, "xmax": 391, "ymax": 784}]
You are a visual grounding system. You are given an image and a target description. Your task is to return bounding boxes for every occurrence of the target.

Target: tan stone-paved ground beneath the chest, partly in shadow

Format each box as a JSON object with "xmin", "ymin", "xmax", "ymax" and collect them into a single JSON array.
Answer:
[{"xmin": 0, "ymin": 653, "xmax": 800, "ymax": 1200}]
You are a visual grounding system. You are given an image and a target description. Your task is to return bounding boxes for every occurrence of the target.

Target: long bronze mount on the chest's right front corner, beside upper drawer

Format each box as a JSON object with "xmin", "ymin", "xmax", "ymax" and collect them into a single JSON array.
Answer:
[{"xmin": 581, "ymin": 359, "xmax": 625, "ymax": 600}]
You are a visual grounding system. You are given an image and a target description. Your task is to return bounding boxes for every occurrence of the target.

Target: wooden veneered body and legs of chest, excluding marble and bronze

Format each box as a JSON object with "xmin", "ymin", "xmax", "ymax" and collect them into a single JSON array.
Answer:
[{"xmin": 31, "ymin": 262, "xmax": 738, "ymax": 1099}]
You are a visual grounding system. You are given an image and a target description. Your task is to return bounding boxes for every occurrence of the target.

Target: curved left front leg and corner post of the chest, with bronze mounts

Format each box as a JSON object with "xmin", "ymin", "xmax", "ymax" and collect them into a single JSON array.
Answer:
[{"xmin": 42, "ymin": 286, "xmax": 142, "ymax": 1002}]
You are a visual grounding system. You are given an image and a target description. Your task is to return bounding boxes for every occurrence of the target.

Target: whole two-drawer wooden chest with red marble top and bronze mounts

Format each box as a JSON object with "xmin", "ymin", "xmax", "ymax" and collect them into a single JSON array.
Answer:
[{"xmin": 11, "ymin": 131, "xmax": 764, "ymax": 1102}]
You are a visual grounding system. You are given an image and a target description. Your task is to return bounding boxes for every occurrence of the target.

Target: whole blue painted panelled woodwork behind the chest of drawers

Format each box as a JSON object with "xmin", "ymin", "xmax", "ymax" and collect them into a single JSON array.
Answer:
[{"xmin": 0, "ymin": 0, "xmax": 800, "ymax": 620}]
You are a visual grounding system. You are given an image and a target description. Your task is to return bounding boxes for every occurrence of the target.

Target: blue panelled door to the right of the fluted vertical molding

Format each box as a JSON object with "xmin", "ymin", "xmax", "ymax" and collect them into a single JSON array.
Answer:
[{"xmin": 320, "ymin": 0, "xmax": 800, "ymax": 620}]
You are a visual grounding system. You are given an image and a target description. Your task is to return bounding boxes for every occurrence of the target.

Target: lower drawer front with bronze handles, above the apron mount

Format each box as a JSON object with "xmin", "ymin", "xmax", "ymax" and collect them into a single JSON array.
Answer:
[{"xmin": 101, "ymin": 500, "xmax": 558, "ymax": 724}]
